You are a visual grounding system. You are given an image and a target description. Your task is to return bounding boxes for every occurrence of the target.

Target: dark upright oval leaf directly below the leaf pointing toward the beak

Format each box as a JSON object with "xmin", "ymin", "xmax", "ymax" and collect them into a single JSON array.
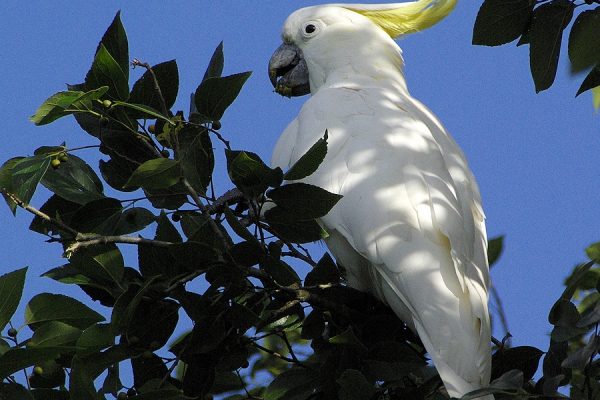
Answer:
[{"xmin": 176, "ymin": 125, "xmax": 215, "ymax": 194}]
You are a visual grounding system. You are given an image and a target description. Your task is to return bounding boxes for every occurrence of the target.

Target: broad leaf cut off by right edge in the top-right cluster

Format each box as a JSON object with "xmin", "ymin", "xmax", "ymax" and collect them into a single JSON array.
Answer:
[{"xmin": 569, "ymin": 8, "xmax": 600, "ymax": 72}]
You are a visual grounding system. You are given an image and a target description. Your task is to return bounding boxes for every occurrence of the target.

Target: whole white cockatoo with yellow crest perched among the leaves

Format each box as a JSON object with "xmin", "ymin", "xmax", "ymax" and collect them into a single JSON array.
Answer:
[{"xmin": 269, "ymin": 0, "xmax": 491, "ymax": 397}]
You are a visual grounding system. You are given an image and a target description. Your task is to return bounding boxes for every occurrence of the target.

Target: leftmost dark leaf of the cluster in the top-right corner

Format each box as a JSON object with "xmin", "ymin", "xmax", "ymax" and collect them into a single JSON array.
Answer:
[{"xmin": 473, "ymin": 0, "xmax": 535, "ymax": 46}]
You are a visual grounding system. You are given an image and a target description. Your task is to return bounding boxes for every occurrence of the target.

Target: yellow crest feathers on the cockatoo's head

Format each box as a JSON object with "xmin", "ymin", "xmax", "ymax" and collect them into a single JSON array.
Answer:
[{"xmin": 340, "ymin": 0, "xmax": 457, "ymax": 38}]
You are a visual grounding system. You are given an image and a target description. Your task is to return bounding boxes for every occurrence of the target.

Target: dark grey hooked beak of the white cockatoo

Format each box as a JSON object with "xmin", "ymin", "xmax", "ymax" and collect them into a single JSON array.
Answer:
[{"xmin": 269, "ymin": 43, "xmax": 310, "ymax": 97}]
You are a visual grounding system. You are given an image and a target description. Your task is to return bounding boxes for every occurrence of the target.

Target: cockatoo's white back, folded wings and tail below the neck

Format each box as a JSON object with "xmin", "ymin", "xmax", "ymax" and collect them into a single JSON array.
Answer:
[{"xmin": 278, "ymin": 88, "xmax": 490, "ymax": 393}]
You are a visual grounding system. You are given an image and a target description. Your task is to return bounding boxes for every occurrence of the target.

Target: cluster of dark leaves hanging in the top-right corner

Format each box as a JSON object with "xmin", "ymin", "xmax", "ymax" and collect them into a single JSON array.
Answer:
[{"xmin": 473, "ymin": 0, "xmax": 600, "ymax": 95}]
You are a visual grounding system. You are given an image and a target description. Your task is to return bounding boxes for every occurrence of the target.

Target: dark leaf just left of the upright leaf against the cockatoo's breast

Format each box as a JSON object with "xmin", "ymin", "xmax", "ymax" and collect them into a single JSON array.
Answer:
[{"xmin": 225, "ymin": 150, "xmax": 283, "ymax": 195}]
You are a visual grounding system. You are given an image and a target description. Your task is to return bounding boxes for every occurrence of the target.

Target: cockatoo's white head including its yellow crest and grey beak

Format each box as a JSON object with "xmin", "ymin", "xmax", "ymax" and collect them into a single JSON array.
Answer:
[{"xmin": 269, "ymin": 0, "xmax": 456, "ymax": 97}]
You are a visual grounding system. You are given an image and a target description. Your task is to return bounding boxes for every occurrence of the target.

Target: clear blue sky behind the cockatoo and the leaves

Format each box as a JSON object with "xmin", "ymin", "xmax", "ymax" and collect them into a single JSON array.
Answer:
[{"xmin": 0, "ymin": 0, "xmax": 600, "ymax": 378}]
